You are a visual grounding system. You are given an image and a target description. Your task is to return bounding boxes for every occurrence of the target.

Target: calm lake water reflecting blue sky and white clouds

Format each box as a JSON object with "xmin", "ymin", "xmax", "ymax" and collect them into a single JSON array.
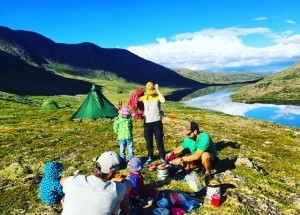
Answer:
[{"xmin": 184, "ymin": 90, "xmax": 300, "ymax": 128}]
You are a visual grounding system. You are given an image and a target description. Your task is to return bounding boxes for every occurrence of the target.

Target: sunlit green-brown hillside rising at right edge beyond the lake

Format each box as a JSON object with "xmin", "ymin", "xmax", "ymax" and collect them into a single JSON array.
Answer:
[{"xmin": 232, "ymin": 61, "xmax": 300, "ymax": 105}]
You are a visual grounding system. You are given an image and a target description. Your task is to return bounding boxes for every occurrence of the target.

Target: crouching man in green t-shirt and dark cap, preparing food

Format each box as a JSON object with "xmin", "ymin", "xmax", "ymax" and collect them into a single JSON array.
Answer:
[{"xmin": 166, "ymin": 122, "xmax": 219, "ymax": 182}]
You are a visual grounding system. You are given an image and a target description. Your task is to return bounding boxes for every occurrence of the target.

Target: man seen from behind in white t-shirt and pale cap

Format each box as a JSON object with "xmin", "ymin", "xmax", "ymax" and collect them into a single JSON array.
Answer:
[{"xmin": 60, "ymin": 151, "xmax": 132, "ymax": 215}]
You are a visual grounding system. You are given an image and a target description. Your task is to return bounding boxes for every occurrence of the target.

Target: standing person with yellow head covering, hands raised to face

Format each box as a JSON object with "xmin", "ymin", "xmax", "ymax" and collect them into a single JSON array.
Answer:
[{"xmin": 139, "ymin": 82, "xmax": 166, "ymax": 166}]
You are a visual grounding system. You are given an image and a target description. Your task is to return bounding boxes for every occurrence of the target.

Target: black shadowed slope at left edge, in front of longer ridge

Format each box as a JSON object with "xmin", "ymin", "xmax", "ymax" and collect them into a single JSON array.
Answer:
[{"xmin": 0, "ymin": 50, "xmax": 91, "ymax": 95}]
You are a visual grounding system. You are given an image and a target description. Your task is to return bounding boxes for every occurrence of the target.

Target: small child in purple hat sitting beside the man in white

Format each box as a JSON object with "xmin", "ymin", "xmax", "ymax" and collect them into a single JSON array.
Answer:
[{"xmin": 128, "ymin": 157, "xmax": 155, "ymax": 204}]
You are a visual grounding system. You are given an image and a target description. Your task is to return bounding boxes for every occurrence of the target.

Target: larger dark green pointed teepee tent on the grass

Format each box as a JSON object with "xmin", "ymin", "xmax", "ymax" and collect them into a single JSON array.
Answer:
[{"xmin": 71, "ymin": 84, "xmax": 118, "ymax": 119}]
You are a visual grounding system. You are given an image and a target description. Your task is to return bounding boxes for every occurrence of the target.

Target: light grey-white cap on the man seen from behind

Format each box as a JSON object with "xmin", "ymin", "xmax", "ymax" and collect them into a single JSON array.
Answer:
[{"xmin": 97, "ymin": 151, "xmax": 121, "ymax": 174}]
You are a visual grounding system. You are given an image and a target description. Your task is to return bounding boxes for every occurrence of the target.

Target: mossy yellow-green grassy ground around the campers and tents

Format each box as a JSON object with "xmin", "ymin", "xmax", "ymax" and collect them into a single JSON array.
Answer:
[{"xmin": 0, "ymin": 82, "xmax": 300, "ymax": 214}]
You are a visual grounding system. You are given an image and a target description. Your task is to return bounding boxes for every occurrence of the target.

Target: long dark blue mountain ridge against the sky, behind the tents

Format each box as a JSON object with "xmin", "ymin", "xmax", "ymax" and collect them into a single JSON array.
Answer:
[{"xmin": 0, "ymin": 26, "xmax": 205, "ymax": 93}]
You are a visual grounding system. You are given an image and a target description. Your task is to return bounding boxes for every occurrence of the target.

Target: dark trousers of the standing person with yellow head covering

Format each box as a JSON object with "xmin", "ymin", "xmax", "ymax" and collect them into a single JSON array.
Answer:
[{"xmin": 144, "ymin": 121, "xmax": 166, "ymax": 159}]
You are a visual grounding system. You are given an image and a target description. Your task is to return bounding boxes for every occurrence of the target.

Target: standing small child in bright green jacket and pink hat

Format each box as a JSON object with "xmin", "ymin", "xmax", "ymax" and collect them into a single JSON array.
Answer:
[{"xmin": 113, "ymin": 106, "xmax": 134, "ymax": 161}]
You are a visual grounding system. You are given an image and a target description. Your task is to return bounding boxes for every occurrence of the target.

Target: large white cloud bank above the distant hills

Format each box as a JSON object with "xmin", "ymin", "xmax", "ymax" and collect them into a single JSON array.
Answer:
[{"xmin": 127, "ymin": 27, "xmax": 300, "ymax": 71}]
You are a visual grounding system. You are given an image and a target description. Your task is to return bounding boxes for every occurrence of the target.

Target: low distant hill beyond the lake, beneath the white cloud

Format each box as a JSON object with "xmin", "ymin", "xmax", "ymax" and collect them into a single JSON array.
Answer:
[{"xmin": 174, "ymin": 69, "xmax": 270, "ymax": 84}]
